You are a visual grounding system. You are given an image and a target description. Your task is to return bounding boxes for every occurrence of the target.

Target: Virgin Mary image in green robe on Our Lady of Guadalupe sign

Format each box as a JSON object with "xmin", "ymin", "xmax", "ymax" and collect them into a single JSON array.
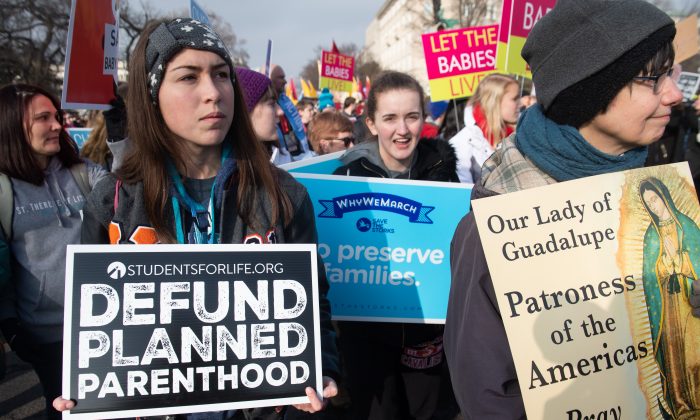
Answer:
[{"xmin": 639, "ymin": 178, "xmax": 700, "ymax": 419}]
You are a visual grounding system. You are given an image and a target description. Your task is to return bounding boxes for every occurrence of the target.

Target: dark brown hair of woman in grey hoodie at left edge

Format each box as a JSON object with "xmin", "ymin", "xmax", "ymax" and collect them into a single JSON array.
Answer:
[{"xmin": 0, "ymin": 83, "xmax": 80, "ymax": 185}]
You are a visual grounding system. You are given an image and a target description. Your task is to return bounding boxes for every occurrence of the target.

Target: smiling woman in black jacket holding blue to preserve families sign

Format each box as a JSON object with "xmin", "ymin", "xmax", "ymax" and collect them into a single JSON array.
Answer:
[{"xmin": 335, "ymin": 72, "xmax": 459, "ymax": 420}]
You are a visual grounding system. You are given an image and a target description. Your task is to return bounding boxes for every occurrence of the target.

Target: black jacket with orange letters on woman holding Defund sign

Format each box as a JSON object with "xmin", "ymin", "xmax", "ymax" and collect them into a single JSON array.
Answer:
[{"xmin": 81, "ymin": 168, "xmax": 340, "ymax": 379}]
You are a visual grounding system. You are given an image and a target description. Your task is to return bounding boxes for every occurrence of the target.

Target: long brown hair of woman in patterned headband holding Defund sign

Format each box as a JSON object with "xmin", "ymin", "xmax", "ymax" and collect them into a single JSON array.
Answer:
[{"xmin": 119, "ymin": 20, "xmax": 292, "ymax": 243}]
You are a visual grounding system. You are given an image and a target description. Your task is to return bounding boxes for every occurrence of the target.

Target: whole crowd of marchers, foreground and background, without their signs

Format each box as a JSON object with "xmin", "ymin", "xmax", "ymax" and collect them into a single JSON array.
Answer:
[{"xmin": 0, "ymin": 0, "xmax": 700, "ymax": 420}]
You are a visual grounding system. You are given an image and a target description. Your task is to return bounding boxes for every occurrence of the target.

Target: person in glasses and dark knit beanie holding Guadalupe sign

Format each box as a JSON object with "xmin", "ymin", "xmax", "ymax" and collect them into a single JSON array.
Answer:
[{"xmin": 444, "ymin": 0, "xmax": 682, "ymax": 419}]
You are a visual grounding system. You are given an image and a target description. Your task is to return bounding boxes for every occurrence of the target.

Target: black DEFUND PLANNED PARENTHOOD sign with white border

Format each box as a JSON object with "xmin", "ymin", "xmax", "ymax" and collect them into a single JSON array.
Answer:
[{"xmin": 63, "ymin": 245, "xmax": 322, "ymax": 418}]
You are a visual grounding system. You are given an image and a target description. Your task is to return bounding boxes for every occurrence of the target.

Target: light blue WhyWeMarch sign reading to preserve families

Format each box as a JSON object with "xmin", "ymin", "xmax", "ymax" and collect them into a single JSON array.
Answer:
[{"xmin": 293, "ymin": 173, "xmax": 472, "ymax": 323}]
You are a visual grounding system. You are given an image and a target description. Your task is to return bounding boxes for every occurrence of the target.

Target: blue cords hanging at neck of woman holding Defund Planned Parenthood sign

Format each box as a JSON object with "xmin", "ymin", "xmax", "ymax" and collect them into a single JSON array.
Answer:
[{"xmin": 166, "ymin": 143, "xmax": 231, "ymax": 244}]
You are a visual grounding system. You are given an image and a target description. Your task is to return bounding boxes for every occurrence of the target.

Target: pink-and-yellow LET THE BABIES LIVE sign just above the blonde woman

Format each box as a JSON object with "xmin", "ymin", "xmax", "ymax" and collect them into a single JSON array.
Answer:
[{"xmin": 422, "ymin": 25, "xmax": 498, "ymax": 102}]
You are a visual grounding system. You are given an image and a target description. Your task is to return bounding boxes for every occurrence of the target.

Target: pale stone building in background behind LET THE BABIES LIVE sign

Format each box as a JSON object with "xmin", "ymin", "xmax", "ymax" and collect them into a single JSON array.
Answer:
[{"xmin": 363, "ymin": 0, "xmax": 502, "ymax": 92}]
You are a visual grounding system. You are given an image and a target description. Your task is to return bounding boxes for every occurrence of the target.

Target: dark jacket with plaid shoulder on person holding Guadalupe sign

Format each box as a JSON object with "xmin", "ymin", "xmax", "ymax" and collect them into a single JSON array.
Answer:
[{"xmin": 444, "ymin": 136, "xmax": 556, "ymax": 420}]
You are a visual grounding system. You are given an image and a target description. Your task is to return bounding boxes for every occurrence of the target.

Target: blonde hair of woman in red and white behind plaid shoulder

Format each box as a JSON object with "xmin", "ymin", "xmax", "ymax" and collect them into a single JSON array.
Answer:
[{"xmin": 469, "ymin": 73, "xmax": 518, "ymax": 146}]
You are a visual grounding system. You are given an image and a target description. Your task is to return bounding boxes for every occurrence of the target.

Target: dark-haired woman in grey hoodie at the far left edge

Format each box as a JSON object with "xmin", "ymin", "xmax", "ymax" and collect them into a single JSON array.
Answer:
[{"xmin": 0, "ymin": 84, "xmax": 105, "ymax": 418}]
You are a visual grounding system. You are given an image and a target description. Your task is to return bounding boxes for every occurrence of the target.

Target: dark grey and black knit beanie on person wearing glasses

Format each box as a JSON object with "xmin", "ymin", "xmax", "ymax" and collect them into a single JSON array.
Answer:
[{"xmin": 522, "ymin": 0, "xmax": 676, "ymax": 128}]
